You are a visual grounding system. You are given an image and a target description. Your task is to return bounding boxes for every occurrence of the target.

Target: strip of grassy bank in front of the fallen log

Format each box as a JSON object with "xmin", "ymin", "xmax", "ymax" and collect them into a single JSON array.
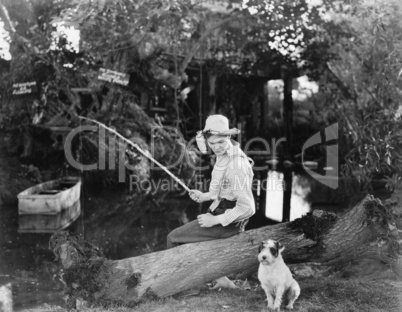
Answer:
[{"xmin": 24, "ymin": 277, "xmax": 402, "ymax": 312}]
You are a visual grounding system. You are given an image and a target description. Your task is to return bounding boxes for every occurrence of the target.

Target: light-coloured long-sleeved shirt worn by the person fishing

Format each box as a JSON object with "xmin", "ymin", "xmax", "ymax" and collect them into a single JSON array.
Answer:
[{"xmin": 209, "ymin": 141, "xmax": 255, "ymax": 226}]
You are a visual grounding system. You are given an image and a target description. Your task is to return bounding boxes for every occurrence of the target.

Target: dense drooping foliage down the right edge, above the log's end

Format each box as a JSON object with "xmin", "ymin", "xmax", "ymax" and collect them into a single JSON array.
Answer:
[{"xmin": 320, "ymin": 0, "xmax": 402, "ymax": 190}]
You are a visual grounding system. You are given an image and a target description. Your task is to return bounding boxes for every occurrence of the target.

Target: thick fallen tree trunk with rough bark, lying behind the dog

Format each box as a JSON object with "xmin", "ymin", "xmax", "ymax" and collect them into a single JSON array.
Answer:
[{"xmin": 51, "ymin": 195, "xmax": 402, "ymax": 306}]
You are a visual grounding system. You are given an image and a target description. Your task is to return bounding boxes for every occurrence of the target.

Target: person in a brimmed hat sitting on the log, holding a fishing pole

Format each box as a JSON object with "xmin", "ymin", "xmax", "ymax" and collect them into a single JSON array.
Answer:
[{"xmin": 167, "ymin": 115, "xmax": 255, "ymax": 288}]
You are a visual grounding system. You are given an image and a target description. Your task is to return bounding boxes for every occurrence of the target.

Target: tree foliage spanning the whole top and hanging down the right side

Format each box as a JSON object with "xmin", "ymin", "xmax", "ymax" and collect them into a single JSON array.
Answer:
[{"xmin": 0, "ymin": 0, "xmax": 402, "ymax": 195}]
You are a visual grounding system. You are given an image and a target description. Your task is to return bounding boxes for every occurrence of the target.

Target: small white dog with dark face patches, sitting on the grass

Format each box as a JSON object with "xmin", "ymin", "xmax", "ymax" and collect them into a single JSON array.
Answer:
[{"xmin": 258, "ymin": 239, "xmax": 300, "ymax": 311}]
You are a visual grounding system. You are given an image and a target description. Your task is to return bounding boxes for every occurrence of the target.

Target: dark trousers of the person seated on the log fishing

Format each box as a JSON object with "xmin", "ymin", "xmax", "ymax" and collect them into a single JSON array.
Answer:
[{"xmin": 167, "ymin": 220, "xmax": 240, "ymax": 248}]
